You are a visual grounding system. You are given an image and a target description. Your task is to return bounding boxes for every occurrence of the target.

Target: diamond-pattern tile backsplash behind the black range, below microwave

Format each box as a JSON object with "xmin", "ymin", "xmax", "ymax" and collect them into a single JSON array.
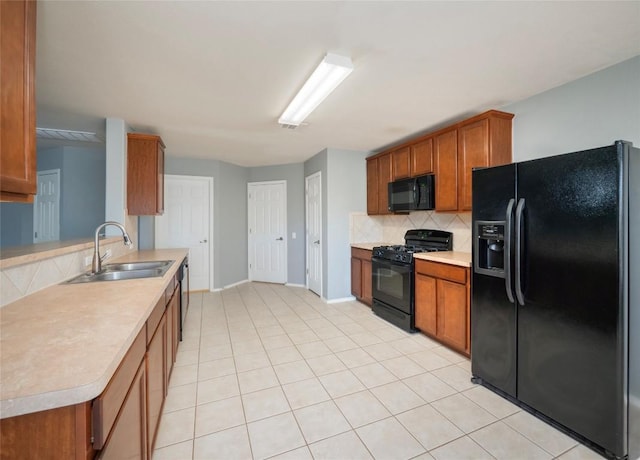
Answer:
[{"xmin": 349, "ymin": 211, "xmax": 471, "ymax": 252}]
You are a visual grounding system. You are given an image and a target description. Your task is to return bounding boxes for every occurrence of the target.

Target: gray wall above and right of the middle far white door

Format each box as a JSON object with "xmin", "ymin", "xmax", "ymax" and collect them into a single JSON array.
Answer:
[{"xmin": 245, "ymin": 163, "xmax": 306, "ymax": 285}]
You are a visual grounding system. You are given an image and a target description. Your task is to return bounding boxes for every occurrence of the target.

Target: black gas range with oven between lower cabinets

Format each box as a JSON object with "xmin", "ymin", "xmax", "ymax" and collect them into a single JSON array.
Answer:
[{"xmin": 371, "ymin": 229, "xmax": 453, "ymax": 332}]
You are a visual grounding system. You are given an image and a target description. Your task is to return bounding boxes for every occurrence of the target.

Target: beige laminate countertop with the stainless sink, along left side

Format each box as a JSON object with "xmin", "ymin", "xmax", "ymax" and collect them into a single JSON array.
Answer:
[{"xmin": 0, "ymin": 249, "xmax": 188, "ymax": 418}]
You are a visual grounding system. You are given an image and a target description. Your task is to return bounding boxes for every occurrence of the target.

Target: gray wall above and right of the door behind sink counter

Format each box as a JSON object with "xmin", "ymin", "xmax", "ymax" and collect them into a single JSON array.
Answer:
[{"xmin": 162, "ymin": 157, "xmax": 249, "ymax": 289}]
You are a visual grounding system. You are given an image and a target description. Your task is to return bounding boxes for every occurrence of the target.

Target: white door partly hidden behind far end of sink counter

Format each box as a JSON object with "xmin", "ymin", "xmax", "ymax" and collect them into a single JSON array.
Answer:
[{"xmin": 155, "ymin": 175, "xmax": 213, "ymax": 291}]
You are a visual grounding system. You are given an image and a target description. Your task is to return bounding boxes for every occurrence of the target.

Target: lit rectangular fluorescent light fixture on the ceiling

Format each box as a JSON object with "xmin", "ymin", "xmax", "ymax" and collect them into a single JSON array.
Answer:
[{"xmin": 278, "ymin": 53, "xmax": 353, "ymax": 126}]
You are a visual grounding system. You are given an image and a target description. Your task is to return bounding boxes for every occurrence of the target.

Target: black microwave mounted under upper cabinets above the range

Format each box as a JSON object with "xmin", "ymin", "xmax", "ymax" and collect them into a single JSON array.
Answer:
[{"xmin": 389, "ymin": 174, "xmax": 436, "ymax": 212}]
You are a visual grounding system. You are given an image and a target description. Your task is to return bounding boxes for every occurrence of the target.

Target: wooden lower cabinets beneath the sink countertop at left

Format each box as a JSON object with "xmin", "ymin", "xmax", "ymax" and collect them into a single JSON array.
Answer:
[{"xmin": 0, "ymin": 279, "xmax": 181, "ymax": 460}]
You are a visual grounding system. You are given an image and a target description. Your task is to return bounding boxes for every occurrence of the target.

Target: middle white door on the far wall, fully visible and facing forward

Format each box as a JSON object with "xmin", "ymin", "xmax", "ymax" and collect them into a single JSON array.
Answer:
[{"xmin": 248, "ymin": 181, "xmax": 287, "ymax": 283}]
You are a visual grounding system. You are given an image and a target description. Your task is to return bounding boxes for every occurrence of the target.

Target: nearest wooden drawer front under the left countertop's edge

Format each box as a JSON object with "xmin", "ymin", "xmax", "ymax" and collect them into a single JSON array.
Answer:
[{"xmin": 92, "ymin": 328, "xmax": 147, "ymax": 450}]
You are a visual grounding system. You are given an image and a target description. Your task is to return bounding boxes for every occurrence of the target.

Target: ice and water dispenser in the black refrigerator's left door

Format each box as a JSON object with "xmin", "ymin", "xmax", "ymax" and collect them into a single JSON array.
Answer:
[{"xmin": 474, "ymin": 220, "xmax": 506, "ymax": 278}]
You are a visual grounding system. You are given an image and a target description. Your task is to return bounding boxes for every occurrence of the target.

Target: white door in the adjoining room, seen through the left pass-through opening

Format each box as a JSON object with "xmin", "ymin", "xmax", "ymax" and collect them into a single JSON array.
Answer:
[{"xmin": 33, "ymin": 169, "xmax": 60, "ymax": 243}]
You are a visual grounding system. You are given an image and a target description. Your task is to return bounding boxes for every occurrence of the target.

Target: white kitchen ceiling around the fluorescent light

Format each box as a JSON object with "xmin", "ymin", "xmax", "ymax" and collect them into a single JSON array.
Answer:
[{"xmin": 36, "ymin": 1, "xmax": 640, "ymax": 166}]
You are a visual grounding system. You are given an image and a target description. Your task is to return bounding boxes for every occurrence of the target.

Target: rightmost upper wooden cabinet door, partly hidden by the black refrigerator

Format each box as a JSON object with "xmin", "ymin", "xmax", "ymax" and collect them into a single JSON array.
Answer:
[{"xmin": 458, "ymin": 118, "xmax": 489, "ymax": 211}]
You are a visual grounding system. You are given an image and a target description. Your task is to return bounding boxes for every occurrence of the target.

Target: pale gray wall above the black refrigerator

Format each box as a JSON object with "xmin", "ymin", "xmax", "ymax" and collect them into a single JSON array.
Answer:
[{"xmin": 501, "ymin": 56, "xmax": 640, "ymax": 161}]
